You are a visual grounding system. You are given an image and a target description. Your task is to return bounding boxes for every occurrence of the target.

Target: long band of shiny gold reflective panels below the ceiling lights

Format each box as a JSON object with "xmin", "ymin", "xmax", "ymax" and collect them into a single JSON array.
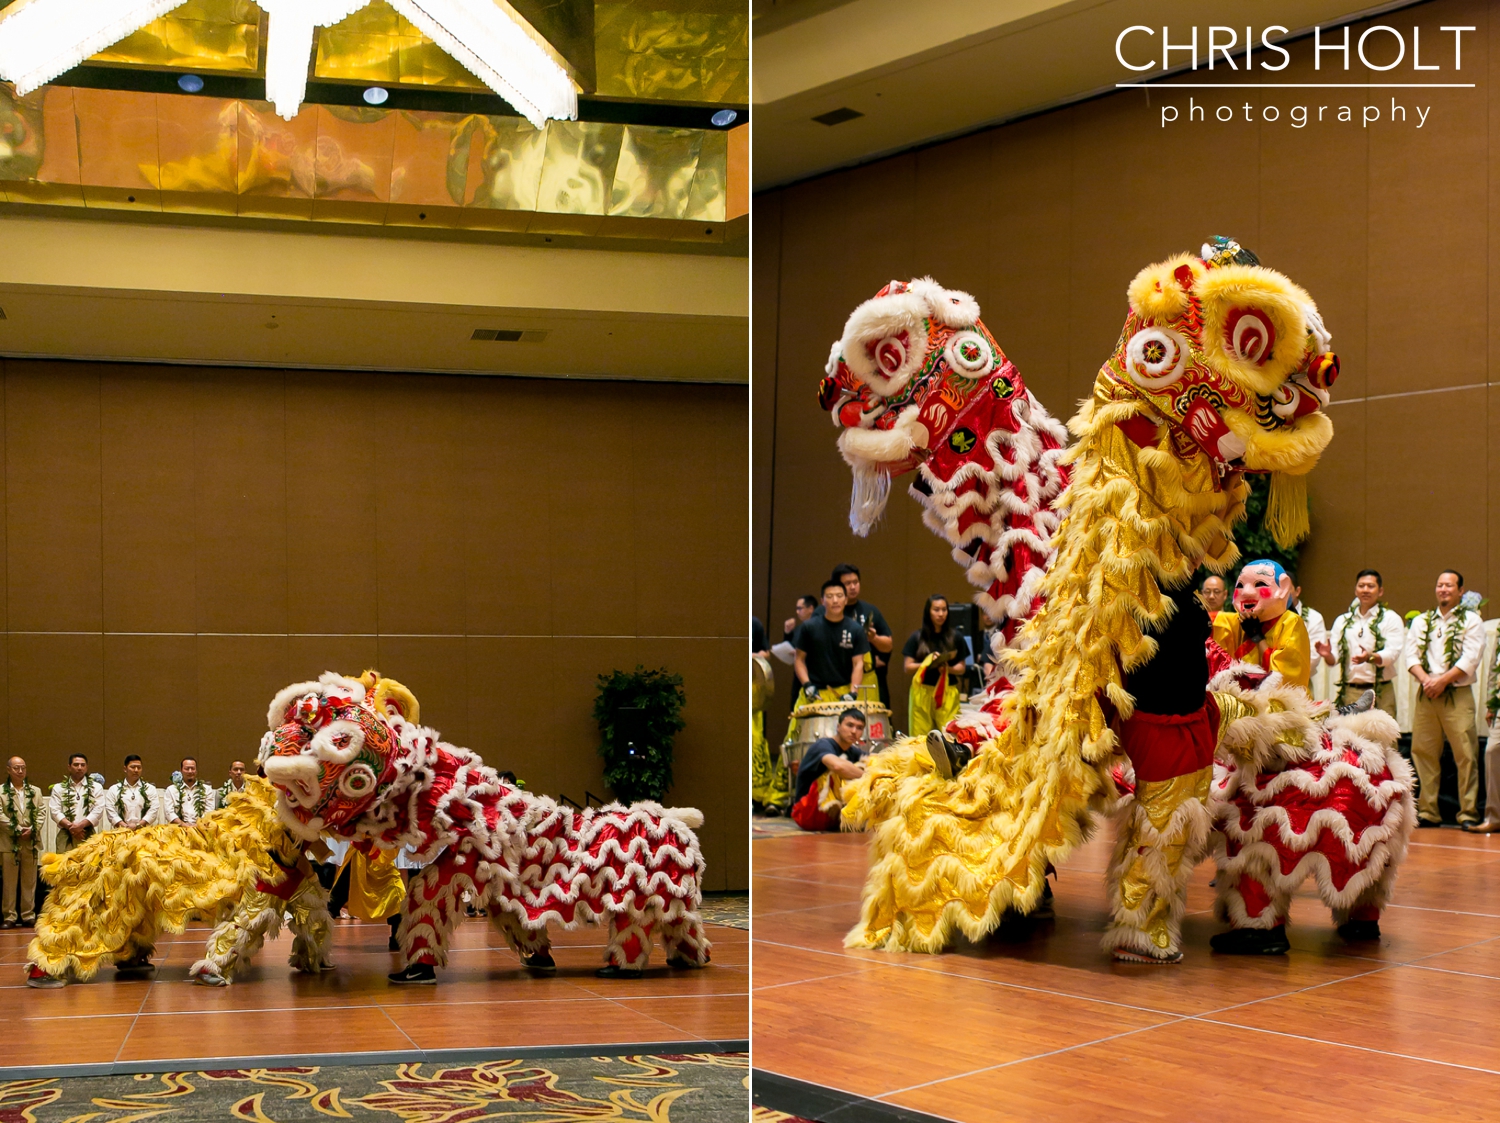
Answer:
[{"xmin": 0, "ymin": 82, "xmax": 732, "ymax": 240}]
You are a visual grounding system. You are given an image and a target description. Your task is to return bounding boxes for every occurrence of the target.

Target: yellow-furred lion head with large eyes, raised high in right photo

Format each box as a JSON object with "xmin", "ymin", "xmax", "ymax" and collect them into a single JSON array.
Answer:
[{"xmin": 1098, "ymin": 238, "xmax": 1338, "ymax": 477}]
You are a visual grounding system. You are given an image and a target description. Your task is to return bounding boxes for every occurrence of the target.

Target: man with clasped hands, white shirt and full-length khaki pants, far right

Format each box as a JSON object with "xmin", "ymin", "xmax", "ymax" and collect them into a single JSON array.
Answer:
[{"xmin": 1403, "ymin": 570, "xmax": 1485, "ymax": 829}]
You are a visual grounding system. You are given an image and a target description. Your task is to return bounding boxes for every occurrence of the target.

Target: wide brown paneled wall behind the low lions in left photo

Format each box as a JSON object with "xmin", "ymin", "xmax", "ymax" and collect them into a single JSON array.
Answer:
[{"xmin": 0, "ymin": 360, "xmax": 749, "ymax": 889}]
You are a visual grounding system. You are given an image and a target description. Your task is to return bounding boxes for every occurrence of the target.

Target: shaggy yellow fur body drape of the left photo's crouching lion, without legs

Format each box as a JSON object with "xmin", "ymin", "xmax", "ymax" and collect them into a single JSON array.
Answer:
[{"xmin": 27, "ymin": 778, "xmax": 285, "ymax": 979}]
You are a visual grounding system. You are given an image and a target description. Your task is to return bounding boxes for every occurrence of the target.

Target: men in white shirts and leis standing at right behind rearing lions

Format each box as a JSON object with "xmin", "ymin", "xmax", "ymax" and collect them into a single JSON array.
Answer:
[{"xmin": 1199, "ymin": 570, "xmax": 1500, "ymax": 834}]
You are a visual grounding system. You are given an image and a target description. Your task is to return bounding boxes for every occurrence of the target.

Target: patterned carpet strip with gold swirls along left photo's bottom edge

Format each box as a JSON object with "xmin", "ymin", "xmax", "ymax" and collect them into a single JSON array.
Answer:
[{"xmin": 0, "ymin": 1053, "xmax": 750, "ymax": 1123}]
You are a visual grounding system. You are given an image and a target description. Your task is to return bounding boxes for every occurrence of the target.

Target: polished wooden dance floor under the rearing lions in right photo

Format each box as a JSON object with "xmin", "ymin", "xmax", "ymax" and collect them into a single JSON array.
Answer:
[{"xmin": 752, "ymin": 829, "xmax": 1500, "ymax": 1123}]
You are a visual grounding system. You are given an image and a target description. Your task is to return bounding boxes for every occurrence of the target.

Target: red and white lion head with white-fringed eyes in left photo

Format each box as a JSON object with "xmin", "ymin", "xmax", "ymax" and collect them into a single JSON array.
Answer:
[{"xmin": 260, "ymin": 672, "xmax": 399, "ymax": 838}]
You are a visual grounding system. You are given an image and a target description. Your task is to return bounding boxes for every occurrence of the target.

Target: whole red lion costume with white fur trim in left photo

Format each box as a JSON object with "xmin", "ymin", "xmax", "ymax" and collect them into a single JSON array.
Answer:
[{"xmin": 260, "ymin": 672, "xmax": 710, "ymax": 982}]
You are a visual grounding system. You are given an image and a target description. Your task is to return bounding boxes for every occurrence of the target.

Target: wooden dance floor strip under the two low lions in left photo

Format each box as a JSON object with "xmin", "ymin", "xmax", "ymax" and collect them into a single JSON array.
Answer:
[{"xmin": 0, "ymin": 919, "xmax": 750, "ymax": 1078}]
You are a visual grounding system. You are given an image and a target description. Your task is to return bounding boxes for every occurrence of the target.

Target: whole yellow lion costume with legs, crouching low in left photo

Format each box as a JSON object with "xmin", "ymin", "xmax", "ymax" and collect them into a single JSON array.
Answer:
[{"xmin": 27, "ymin": 777, "xmax": 330, "ymax": 987}]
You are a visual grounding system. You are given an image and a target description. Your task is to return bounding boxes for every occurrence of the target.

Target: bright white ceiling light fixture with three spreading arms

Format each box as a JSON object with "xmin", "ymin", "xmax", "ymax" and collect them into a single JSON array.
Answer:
[{"xmin": 0, "ymin": 0, "xmax": 578, "ymax": 129}]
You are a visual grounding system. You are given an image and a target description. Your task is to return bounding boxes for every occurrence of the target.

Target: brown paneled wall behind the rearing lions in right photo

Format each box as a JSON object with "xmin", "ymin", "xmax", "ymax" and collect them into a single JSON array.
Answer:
[{"xmin": 753, "ymin": 0, "xmax": 1500, "ymax": 738}]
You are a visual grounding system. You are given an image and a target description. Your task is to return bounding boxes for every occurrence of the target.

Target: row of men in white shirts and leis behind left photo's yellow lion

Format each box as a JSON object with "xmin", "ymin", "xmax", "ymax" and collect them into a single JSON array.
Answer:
[{"xmin": 0, "ymin": 753, "xmax": 245, "ymax": 928}]
